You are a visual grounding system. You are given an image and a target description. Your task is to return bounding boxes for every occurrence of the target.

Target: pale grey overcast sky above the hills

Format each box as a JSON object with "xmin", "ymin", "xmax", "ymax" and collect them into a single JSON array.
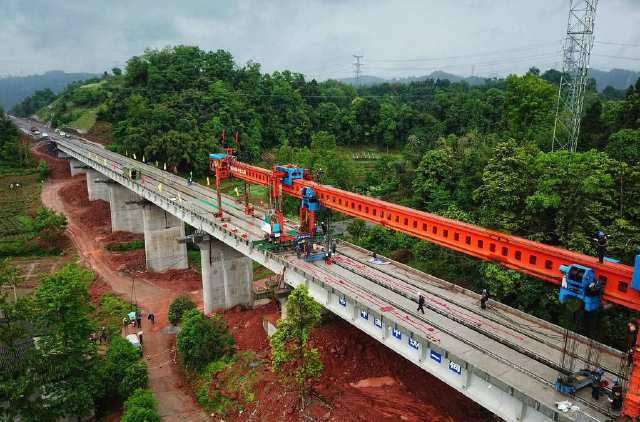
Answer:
[{"xmin": 0, "ymin": 0, "xmax": 640, "ymax": 79}]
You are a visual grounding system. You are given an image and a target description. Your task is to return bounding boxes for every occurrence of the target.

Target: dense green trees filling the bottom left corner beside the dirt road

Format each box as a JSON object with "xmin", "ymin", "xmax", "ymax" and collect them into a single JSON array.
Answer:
[{"xmin": 0, "ymin": 260, "xmax": 148, "ymax": 421}]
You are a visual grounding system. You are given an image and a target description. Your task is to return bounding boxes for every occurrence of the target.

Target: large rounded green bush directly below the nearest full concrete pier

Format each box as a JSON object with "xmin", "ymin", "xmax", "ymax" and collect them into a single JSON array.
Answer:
[{"xmin": 176, "ymin": 309, "xmax": 233, "ymax": 371}]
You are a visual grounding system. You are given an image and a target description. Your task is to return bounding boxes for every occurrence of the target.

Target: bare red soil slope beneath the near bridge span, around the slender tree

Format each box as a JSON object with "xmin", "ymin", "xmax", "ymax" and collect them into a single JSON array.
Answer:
[{"xmin": 224, "ymin": 302, "xmax": 491, "ymax": 421}]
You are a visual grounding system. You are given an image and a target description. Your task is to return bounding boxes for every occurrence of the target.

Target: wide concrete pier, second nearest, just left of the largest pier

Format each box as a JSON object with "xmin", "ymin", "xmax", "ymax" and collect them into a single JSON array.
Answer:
[{"xmin": 142, "ymin": 204, "xmax": 189, "ymax": 272}]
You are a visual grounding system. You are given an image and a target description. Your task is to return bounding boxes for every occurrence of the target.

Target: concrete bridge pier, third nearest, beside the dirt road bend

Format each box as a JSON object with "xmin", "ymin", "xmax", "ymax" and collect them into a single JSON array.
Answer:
[{"xmin": 106, "ymin": 183, "xmax": 144, "ymax": 233}]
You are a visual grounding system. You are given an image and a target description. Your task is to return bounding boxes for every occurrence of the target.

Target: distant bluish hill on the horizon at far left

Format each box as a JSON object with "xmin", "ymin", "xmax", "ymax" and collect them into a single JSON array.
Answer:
[{"xmin": 0, "ymin": 70, "xmax": 96, "ymax": 110}]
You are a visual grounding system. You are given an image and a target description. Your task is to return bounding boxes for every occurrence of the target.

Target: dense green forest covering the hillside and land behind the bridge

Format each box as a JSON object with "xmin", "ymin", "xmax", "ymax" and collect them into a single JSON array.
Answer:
[{"xmin": 13, "ymin": 46, "xmax": 640, "ymax": 347}]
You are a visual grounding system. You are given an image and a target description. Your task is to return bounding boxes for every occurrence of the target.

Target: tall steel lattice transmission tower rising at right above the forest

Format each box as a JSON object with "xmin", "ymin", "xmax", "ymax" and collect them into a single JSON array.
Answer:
[{"xmin": 552, "ymin": 0, "xmax": 598, "ymax": 152}]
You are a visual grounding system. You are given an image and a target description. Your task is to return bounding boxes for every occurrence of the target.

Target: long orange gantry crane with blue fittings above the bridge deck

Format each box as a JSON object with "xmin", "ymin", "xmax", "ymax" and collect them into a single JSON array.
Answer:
[{"xmin": 209, "ymin": 148, "xmax": 640, "ymax": 418}]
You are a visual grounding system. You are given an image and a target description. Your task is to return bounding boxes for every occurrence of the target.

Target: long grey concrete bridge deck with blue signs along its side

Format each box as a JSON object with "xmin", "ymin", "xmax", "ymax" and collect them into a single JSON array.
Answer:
[{"xmin": 13, "ymin": 121, "xmax": 625, "ymax": 421}]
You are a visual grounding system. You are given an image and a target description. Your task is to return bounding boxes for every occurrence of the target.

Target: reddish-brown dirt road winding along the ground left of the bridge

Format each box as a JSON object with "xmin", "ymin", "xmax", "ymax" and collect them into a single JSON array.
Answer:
[{"xmin": 42, "ymin": 176, "xmax": 211, "ymax": 422}]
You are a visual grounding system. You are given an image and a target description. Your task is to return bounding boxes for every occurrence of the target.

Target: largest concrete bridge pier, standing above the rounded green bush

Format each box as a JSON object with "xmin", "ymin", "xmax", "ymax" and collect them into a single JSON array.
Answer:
[{"xmin": 198, "ymin": 239, "xmax": 253, "ymax": 314}]
